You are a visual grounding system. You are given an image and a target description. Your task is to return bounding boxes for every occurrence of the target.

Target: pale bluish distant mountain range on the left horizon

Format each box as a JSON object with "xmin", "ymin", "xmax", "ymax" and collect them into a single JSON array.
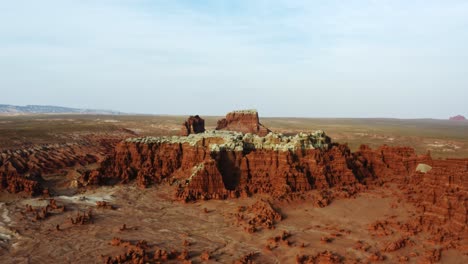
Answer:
[{"xmin": 0, "ymin": 104, "xmax": 124, "ymax": 115}]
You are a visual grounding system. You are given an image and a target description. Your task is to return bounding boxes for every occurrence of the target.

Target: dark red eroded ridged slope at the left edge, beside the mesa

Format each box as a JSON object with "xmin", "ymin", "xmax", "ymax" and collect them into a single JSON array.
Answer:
[{"xmin": 0, "ymin": 135, "xmax": 128, "ymax": 195}]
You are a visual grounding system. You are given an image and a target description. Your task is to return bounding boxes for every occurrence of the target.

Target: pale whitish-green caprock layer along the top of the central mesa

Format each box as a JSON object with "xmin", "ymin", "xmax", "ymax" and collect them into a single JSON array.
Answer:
[{"xmin": 125, "ymin": 130, "xmax": 331, "ymax": 152}]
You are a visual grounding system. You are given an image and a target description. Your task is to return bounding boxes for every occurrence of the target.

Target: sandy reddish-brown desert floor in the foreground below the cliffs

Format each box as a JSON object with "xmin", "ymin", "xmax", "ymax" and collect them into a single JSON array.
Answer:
[{"xmin": 0, "ymin": 182, "xmax": 468, "ymax": 263}]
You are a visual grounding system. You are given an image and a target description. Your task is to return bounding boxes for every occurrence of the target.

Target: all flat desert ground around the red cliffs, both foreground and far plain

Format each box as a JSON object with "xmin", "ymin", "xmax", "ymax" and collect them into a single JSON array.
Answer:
[{"xmin": 0, "ymin": 115, "xmax": 468, "ymax": 263}]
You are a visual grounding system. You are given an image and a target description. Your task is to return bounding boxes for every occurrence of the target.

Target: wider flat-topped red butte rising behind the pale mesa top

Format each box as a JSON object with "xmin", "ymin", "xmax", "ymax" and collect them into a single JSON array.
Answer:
[{"xmin": 216, "ymin": 110, "xmax": 271, "ymax": 136}]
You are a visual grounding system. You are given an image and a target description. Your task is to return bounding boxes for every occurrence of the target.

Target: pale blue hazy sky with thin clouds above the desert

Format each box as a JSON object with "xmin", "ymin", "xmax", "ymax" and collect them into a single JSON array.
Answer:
[{"xmin": 0, "ymin": 0, "xmax": 468, "ymax": 118}]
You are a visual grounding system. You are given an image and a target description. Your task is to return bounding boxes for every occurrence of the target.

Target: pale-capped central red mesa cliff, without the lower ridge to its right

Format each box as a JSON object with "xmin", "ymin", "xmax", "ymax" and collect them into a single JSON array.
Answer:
[{"xmin": 85, "ymin": 132, "xmax": 402, "ymax": 200}]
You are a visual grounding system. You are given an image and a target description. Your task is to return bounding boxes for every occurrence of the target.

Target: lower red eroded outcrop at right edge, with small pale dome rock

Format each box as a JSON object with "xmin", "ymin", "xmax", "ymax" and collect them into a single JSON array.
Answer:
[{"xmin": 353, "ymin": 146, "xmax": 468, "ymax": 241}]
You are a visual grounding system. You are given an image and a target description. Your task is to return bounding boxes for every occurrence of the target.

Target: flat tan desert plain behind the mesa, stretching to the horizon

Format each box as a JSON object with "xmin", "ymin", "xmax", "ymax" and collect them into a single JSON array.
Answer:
[{"xmin": 0, "ymin": 115, "xmax": 468, "ymax": 158}]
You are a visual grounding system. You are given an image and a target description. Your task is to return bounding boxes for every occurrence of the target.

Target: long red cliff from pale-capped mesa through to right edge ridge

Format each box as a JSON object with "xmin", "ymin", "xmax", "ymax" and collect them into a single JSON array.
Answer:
[{"xmin": 85, "ymin": 131, "xmax": 468, "ymax": 240}]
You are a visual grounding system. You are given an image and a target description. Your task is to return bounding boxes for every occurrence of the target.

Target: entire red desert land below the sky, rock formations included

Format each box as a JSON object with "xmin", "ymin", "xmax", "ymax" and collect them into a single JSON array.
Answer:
[{"xmin": 0, "ymin": 112, "xmax": 468, "ymax": 263}]
